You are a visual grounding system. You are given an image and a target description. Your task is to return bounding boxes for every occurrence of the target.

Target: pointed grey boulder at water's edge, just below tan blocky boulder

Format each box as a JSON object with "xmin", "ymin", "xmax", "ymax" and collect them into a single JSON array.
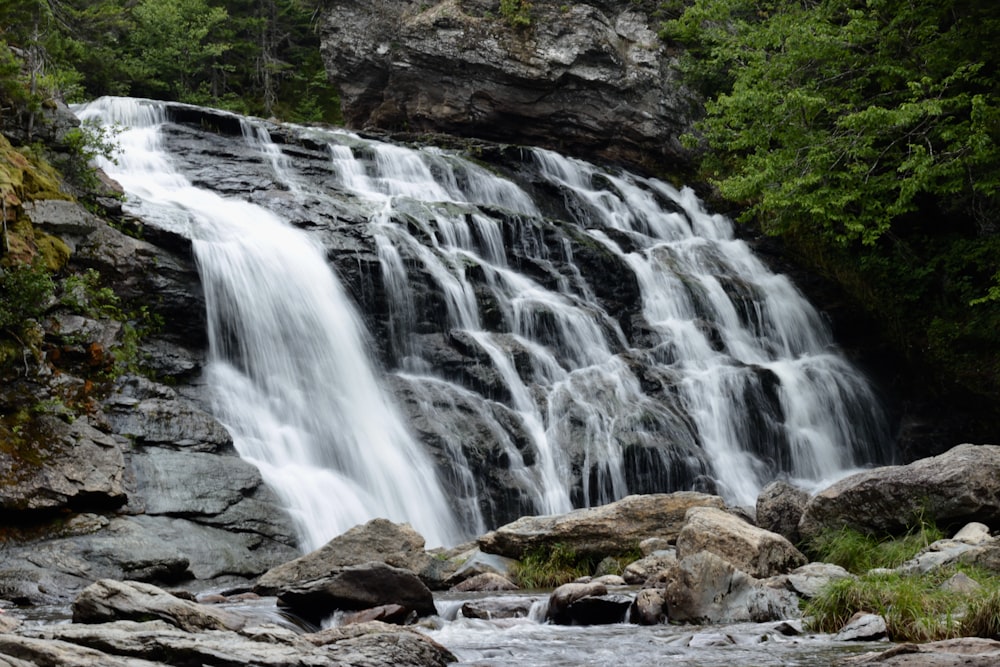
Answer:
[{"xmin": 663, "ymin": 551, "xmax": 801, "ymax": 623}]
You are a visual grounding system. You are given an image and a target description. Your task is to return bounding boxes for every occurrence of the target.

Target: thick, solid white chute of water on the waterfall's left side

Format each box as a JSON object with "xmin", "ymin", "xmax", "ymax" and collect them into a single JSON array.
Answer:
[{"xmin": 77, "ymin": 98, "xmax": 458, "ymax": 549}]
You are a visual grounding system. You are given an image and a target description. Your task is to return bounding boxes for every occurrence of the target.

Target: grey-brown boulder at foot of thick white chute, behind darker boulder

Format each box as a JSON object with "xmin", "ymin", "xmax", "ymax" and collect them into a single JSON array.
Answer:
[{"xmin": 254, "ymin": 519, "xmax": 434, "ymax": 595}]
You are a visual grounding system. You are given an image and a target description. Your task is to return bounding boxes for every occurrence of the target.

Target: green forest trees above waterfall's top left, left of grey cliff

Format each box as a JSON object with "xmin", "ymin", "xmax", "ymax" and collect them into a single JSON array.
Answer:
[{"xmin": 0, "ymin": 0, "xmax": 339, "ymax": 122}]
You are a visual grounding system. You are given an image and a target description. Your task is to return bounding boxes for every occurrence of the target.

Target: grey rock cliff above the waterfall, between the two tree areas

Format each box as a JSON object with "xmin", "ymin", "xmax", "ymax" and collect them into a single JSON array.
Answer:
[{"xmin": 321, "ymin": 0, "xmax": 693, "ymax": 175}]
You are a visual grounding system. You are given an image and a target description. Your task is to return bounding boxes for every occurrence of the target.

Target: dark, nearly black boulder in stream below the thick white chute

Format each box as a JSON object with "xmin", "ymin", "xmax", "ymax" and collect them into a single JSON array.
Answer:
[{"xmin": 278, "ymin": 562, "xmax": 437, "ymax": 624}]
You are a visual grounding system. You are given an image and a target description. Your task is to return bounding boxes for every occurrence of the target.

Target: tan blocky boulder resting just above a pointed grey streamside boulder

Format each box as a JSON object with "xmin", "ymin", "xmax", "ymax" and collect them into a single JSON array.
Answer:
[{"xmin": 677, "ymin": 507, "xmax": 807, "ymax": 578}]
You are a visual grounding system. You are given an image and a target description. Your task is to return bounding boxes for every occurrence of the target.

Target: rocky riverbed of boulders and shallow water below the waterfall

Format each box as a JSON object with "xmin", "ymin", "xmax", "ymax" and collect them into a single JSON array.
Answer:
[{"xmin": 0, "ymin": 445, "xmax": 1000, "ymax": 665}]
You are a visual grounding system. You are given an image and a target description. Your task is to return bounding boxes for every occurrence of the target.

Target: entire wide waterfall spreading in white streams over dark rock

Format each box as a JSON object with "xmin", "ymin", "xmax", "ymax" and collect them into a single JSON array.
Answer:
[{"xmin": 74, "ymin": 100, "xmax": 889, "ymax": 546}]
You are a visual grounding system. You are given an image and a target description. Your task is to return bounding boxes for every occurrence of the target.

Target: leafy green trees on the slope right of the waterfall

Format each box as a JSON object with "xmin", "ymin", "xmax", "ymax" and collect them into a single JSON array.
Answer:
[{"xmin": 664, "ymin": 0, "xmax": 1000, "ymax": 422}]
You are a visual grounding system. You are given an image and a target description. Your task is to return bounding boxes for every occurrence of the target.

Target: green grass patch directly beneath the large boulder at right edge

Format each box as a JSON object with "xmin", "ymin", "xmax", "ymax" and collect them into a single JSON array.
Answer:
[{"xmin": 806, "ymin": 523, "xmax": 942, "ymax": 574}]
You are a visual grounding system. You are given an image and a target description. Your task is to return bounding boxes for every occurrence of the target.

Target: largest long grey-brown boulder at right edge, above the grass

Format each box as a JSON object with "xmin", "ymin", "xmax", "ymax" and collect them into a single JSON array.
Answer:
[{"xmin": 799, "ymin": 444, "xmax": 1000, "ymax": 538}]
